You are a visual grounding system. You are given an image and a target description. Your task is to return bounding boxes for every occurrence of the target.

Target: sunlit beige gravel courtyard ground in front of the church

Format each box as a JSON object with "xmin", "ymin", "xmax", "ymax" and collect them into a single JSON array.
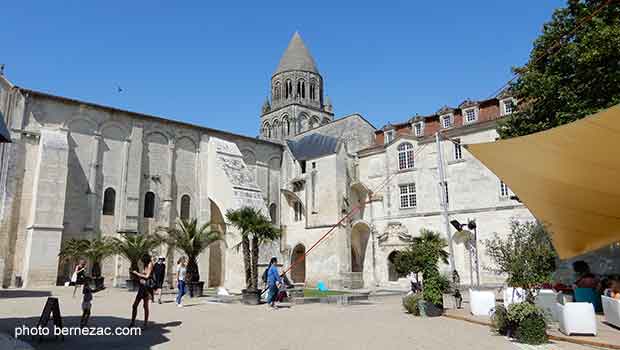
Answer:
[{"xmin": 0, "ymin": 288, "xmax": 583, "ymax": 350}]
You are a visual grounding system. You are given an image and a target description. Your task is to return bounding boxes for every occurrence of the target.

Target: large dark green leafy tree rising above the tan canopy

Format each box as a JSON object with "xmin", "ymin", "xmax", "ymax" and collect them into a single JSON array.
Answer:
[{"xmin": 498, "ymin": 0, "xmax": 620, "ymax": 138}]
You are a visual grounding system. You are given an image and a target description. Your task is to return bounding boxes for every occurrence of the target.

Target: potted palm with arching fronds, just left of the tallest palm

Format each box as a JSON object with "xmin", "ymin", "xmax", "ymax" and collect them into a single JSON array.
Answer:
[{"xmin": 164, "ymin": 218, "xmax": 223, "ymax": 297}]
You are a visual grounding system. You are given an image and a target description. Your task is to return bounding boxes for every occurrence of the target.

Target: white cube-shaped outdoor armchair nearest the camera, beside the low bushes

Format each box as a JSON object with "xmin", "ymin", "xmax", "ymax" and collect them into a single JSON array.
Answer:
[{"xmin": 555, "ymin": 303, "xmax": 596, "ymax": 335}]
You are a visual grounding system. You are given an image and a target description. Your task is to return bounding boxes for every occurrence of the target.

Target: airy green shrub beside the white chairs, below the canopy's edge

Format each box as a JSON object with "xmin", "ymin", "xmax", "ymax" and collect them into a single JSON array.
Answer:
[{"xmin": 484, "ymin": 221, "xmax": 557, "ymax": 302}]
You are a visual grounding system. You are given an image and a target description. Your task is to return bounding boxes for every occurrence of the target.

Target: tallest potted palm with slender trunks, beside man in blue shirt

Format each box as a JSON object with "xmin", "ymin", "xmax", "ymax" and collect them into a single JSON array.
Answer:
[{"xmin": 226, "ymin": 207, "xmax": 280, "ymax": 305}]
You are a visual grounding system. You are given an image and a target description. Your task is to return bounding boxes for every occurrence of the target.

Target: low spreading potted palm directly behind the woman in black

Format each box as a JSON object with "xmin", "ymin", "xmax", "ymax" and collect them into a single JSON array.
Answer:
[{"xmin": 113, "ymin": 233, "xmax": 163, "ymax": 290}]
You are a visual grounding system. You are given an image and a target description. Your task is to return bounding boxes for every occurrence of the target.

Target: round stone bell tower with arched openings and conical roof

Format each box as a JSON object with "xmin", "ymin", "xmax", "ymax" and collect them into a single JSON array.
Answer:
[{"xmin": 260, "ymin": 32, "xmax": 334, "ymax": 140}]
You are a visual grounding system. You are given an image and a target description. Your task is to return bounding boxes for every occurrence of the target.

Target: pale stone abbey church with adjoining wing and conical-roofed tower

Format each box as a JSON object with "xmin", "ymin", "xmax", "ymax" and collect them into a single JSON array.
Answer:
[{"xmin": 0, "ymin": 33, "xmax": 533, "ymax": 291}]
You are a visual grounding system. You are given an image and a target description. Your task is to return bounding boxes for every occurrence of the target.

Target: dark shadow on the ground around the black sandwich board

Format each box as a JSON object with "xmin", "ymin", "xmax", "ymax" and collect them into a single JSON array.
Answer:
[{"xmin": 0, "ymin": 316, "xmax": 182, "ymax": 350}]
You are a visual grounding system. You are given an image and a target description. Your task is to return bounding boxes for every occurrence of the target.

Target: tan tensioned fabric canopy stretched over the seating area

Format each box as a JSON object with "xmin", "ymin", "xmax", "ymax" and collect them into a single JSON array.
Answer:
[{"xmin": 467, "ymin": 105, "xmax": 620, "ymax": 259}]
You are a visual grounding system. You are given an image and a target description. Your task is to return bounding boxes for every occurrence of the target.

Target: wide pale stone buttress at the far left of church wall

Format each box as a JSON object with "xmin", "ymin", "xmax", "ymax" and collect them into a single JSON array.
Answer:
[{"xmin": 22, "ymin": 129, "xmax": 69, "ymax": 287}]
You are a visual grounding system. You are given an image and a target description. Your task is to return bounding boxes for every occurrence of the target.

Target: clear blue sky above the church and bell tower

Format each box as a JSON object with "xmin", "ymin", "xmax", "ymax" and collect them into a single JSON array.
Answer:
[{"xmin": 0, "ymin": 0, "xmax": 564, "ymax": 136}]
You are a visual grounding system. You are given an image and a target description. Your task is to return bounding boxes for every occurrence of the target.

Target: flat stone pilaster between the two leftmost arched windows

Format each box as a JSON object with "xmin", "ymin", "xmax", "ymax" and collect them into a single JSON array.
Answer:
[{"xmin": 120, "ymin": 123, "xmax": 144, "ymax": 232}]
